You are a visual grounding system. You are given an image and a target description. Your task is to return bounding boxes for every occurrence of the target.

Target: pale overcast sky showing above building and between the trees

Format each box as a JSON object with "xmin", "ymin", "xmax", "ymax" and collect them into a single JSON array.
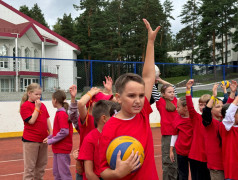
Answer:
[{"xmin": 3, "ymin": 0, "xmax": 186, "ymax": 34}]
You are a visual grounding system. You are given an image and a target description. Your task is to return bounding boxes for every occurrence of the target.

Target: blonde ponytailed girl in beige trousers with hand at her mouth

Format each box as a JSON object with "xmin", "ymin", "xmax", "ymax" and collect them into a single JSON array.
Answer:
[{"xmin": 20, "ymin": 83, "xmax": 52, "ymax": 179}]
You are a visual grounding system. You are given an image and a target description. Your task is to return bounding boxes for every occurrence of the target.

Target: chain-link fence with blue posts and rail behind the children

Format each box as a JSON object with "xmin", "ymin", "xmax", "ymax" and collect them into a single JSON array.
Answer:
[{"xmin": 0, "ymin": 56, "xmax": 238, "ymax": 101}]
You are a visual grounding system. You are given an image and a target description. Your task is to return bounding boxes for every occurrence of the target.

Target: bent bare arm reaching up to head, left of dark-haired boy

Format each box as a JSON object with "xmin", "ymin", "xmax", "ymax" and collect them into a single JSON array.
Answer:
[{"xmin": 78, "ymin": 87, "xmax": 100, "ymax": 124}]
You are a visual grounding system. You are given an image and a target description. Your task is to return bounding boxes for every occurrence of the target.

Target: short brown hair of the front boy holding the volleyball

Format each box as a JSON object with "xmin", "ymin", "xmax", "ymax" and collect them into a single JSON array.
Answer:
[{"xmin": 115, "ymin": 73, "xmax": 145, "ymax": 94}]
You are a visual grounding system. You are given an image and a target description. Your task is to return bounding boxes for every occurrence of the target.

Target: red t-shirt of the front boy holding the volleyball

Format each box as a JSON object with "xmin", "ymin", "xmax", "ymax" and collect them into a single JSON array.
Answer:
[{"xmin": 99, "ymin": 98, "xmax": 159, "ymax": 180}]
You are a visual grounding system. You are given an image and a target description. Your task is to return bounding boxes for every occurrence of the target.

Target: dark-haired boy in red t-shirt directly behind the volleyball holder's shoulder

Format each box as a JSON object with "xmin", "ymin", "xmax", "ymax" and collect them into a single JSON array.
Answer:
[{"xmin": 78, "ymin": 100, "xmax": 120, "ymax": 179}]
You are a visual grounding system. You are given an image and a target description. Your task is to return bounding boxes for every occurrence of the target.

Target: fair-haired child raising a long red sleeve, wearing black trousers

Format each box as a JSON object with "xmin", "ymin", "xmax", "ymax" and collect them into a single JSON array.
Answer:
[{"xmin": 186, "ymin": 79, "xmax": 211, "ymax": 180}]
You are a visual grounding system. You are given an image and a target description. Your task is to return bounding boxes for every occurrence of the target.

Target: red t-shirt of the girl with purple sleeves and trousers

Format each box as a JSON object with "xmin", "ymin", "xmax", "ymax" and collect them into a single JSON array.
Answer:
[{"xmin": 52, "ymin": 111, "xmax": 73, "ymax": 154}]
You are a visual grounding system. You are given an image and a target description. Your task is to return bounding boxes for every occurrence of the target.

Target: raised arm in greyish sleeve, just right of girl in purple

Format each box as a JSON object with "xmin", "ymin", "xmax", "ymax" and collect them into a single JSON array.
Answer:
[{"xmin": 68, "ymin": 85, "xmax": 79, "ymax": 130}]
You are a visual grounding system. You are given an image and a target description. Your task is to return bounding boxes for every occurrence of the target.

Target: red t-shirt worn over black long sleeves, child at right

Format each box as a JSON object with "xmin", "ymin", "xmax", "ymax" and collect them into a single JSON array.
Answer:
[{"xmin": 204, "ymin": 118, "xmax": 224, "ymax": 170}]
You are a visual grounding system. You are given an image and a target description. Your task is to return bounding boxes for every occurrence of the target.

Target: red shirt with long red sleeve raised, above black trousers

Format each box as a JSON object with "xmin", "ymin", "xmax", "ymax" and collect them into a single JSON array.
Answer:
[{"xmin": 186, "ymin": 96, "xmax": 207, "ymax": 162}]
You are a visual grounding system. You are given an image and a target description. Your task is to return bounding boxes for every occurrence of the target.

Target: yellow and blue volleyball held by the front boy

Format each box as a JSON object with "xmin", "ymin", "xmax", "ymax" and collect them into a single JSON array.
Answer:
[{"xmin": 106, "ymin": 136, "xmax": 145, "ymax": 170}]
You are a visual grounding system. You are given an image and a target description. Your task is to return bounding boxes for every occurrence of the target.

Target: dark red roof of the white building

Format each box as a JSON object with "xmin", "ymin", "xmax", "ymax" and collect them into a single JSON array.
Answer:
[{"xmin": 0, "ymin": 0, "xmax": 80, "ymax": 51}]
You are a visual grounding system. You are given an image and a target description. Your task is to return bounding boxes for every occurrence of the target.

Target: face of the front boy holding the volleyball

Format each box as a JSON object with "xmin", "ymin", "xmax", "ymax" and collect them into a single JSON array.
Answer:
[{"xmin": 117, "ymin": 81, "xmax": 145, "ymax": 118}]
